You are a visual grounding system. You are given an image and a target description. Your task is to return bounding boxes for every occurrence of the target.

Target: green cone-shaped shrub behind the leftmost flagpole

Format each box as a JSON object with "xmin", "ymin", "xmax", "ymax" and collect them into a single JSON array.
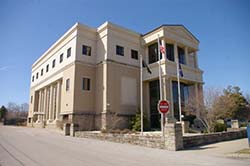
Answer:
[{"xmin": 130, "ymin": 110, "xmax": 149, "ymax": 131}]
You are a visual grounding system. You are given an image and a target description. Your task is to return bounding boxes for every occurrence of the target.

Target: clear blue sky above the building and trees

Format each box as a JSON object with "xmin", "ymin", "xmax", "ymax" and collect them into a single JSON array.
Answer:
[{"xmin": 0, "ymin": 0, "xmax": 250, "ymax": 105}]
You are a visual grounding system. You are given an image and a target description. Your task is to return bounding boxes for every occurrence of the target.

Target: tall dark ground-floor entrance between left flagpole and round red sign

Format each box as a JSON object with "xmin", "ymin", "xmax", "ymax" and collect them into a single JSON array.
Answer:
[{"xmin": 149, "ymin": 80, "xmax": 161, "ymax": 129}]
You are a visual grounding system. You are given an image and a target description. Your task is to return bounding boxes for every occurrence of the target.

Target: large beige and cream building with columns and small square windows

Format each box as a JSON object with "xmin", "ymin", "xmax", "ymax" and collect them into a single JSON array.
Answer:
[{"xmin": 28, "ymin": 22, "xmax": 203, "ymax": 130}]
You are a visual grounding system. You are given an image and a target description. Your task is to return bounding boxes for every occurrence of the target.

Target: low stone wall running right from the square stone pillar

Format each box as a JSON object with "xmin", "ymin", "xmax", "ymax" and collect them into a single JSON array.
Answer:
[{"xmin": 183, "ymin": 129, "xmax": 247, "ymax": 148}]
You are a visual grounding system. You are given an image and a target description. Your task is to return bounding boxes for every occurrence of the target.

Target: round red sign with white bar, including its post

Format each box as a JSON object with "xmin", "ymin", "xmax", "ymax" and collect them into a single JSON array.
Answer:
[{"xmin": 158, "ymin": 100, "xmax": 169, "ymax": 141}]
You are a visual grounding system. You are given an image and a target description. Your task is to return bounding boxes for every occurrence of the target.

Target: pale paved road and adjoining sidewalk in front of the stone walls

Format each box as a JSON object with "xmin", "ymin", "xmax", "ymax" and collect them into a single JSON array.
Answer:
[{"xmin": 0, "ymin": 126, "xmax": 250, "ymax": 166}]
